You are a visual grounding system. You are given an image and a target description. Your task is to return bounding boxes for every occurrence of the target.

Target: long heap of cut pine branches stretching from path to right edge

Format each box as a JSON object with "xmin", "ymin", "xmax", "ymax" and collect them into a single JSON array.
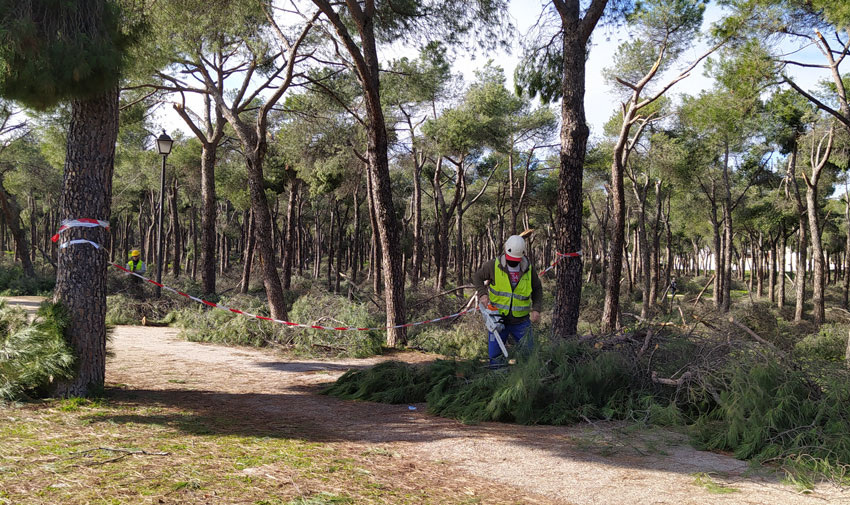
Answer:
[{"xmin": 326, "ymin": 314, "xmax": 850, "ymax": 482}]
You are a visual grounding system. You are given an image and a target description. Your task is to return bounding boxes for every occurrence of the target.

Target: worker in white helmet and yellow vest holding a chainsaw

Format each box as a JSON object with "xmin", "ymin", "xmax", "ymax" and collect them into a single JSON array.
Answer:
[{"xmin": 472, "ymin": 235, "xmax": 543, "ymax": 365}]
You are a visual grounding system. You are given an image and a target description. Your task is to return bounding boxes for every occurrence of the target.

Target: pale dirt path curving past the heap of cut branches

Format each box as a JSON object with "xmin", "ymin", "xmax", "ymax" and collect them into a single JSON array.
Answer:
[{"xmin": 101, "ymin": 326, "xmax": 850, "ymax": 505}]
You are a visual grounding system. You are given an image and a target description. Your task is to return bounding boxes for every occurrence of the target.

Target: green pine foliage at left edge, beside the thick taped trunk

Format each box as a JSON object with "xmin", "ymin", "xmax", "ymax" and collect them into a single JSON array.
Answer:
[{"xmin": 0, "ymin": 302, "xmax": 75, "ymax": 401}]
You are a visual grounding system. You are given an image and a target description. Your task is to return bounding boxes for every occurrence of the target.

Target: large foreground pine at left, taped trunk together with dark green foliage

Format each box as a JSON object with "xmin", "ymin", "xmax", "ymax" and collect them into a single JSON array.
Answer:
[{"xmin": 0, "ymin": 0, "xmax": 141, "ymax": 396}]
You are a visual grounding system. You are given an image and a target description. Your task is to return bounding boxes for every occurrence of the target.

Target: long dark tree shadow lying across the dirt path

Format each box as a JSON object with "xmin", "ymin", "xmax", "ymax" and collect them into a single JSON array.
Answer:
[{"xmin": 89, "ymin": 385, "xmax": 756, "ymax": 483}]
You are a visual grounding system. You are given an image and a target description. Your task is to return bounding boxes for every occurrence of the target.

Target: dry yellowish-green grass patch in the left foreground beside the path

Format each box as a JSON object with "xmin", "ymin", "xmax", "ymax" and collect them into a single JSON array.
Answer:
[{"xmin": 0, "ymin": 389, "xmax": 528, "ymax": 505}]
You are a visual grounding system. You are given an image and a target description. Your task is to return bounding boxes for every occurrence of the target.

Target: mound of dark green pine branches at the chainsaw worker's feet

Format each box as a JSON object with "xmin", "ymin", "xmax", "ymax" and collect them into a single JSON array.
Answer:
[{"xmin": 325, "ymin": 343, "xmax": 650, "ymax": 424}]
